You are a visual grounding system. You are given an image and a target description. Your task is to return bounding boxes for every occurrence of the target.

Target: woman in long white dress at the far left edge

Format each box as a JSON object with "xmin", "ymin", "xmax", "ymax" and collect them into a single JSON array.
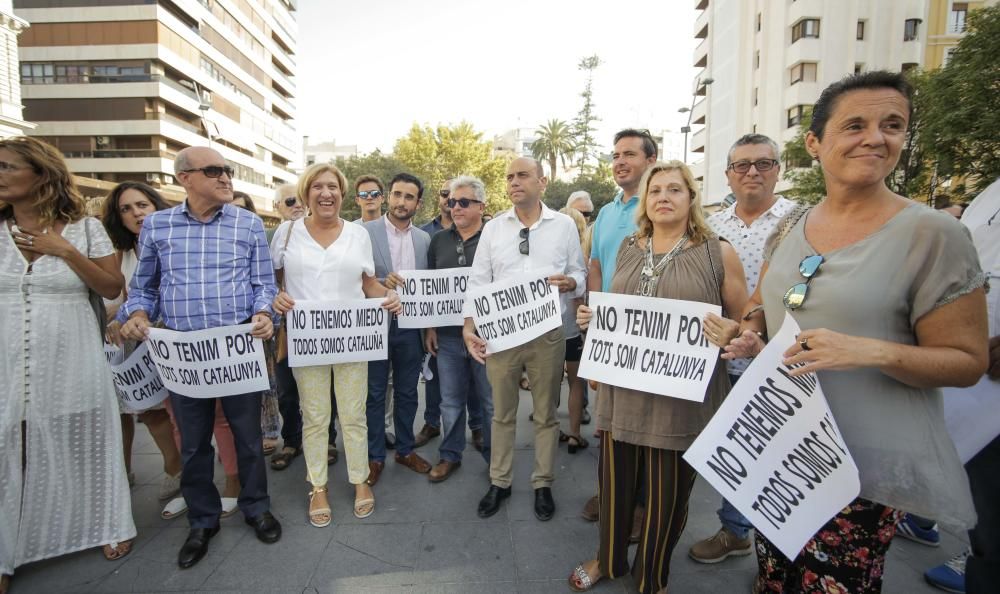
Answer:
[{"xmin": 0, "ymin": 137, "xmax": 135, "ymax": 593}]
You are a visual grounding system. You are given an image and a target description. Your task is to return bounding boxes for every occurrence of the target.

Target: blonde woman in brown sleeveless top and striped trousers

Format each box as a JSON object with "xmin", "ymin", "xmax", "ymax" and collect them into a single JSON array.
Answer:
[{"xmin": 569, "ymin": 161, "xmax": 747, "ymax": 594}]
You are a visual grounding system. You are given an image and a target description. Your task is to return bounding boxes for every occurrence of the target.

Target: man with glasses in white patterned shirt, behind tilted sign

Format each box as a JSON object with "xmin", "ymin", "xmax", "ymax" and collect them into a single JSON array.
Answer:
[{"xmin": 688, "ymin": 134, "xmax": 795, "ymax": 563}]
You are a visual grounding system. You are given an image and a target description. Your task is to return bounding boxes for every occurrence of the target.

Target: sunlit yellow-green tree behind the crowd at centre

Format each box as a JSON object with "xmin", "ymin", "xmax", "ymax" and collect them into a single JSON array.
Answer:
[{"xmin": 393, "ymin": 122, "xmax": 510, "ymax": 223}]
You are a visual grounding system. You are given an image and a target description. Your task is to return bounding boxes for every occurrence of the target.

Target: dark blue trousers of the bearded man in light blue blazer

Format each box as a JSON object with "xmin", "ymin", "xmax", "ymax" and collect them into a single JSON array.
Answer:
[{"xmin": 366, "ymin": 318, "xmax": 424, "ymax": 462}]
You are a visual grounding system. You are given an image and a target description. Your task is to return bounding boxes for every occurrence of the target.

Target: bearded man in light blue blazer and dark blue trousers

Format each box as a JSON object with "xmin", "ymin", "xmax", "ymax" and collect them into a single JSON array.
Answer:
[{"xmin": 364, "ymin": 173, "xmax": 431, "ymax": 485}]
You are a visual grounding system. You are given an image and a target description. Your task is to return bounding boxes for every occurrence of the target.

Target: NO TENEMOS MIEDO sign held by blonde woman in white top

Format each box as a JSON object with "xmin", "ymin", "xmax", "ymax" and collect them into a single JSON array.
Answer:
[{"xmin": 285, "ymin": 299, "xmax": 390, "ymax": 367}]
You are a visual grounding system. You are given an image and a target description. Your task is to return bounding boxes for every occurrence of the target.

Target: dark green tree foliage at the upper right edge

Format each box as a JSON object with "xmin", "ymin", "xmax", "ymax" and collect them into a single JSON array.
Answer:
[{"xmin": 918, "ymin": 5, "xmax": 1000, "ymax": 196}]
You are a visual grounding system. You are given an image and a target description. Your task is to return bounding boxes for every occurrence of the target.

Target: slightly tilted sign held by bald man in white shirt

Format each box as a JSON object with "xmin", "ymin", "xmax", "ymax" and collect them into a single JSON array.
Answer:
[{"xmin": 468, "ymin": 274, "xmax": 562, "ymax": 353}]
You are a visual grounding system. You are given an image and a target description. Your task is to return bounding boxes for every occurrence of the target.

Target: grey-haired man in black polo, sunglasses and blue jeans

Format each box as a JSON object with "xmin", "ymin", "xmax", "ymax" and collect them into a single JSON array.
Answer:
[{"xmin": 424, "ymin": 175, "xmax": 493, "ymax": 483}]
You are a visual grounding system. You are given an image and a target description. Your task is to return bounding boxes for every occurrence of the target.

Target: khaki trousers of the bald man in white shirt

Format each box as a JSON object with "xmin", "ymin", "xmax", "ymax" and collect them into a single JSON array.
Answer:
[{"xmin": 486, "ymin": 327, "xmax": 566, "ymax": 489}]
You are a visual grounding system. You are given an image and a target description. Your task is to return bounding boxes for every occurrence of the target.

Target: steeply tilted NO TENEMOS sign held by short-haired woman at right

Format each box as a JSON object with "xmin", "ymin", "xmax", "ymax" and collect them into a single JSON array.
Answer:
[{"xmin": 684, "ymin": 313, "xmax": 861, "ymax": 559}]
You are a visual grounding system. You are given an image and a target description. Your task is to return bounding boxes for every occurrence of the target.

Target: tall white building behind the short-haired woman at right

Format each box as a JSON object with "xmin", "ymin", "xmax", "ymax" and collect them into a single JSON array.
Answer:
[{"xmin": 690, "ymin": 0, "xmax": 932, "ymax": 204}]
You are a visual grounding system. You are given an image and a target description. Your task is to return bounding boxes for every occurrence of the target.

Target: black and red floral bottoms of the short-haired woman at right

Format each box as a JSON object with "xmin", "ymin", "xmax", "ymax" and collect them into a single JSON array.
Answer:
[{"xmin": 754, "ymin": 497, "xmax": 901, "ymax": 594}]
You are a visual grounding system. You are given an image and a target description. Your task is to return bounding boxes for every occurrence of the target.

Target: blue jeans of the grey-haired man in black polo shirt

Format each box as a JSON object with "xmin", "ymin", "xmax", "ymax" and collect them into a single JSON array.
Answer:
[{"xmin": 437, "ymin": 334, "xmax": 493, "ymax": 466}]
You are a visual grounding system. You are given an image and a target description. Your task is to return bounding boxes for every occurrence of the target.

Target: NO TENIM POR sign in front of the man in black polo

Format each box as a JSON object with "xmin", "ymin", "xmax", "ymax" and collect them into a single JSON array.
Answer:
[{"xmin": 397, "ymin": 268, "xmax": 469, "ymax": 328}]
